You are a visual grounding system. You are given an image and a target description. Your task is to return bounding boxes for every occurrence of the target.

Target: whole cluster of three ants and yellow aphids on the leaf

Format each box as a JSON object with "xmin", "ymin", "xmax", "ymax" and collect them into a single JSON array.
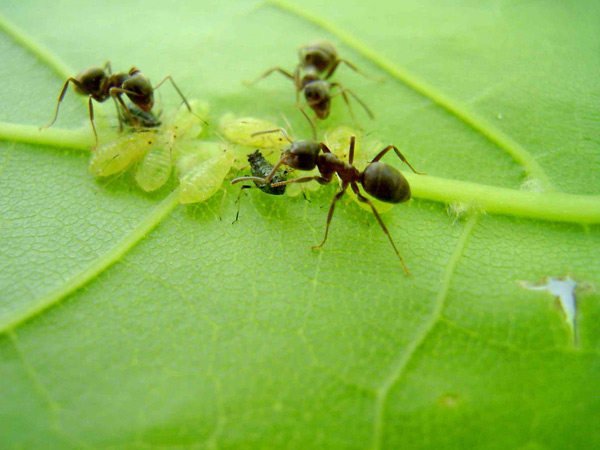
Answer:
[{"xmin": 44, "ymin": 41, "xmax": 420, "ymax": 274}]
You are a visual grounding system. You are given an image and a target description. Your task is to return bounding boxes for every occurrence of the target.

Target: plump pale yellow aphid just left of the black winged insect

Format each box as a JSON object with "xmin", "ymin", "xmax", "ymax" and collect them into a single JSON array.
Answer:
[{"xmin": 179, "ymin": 152, "xmax": 233, "ymax": 203}]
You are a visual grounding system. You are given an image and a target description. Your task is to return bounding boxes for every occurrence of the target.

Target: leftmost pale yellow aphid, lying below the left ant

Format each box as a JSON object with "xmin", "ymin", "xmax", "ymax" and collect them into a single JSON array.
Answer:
[{"xmin": 90, "ymin": 132, "xmax": 156, "ymax": 177}]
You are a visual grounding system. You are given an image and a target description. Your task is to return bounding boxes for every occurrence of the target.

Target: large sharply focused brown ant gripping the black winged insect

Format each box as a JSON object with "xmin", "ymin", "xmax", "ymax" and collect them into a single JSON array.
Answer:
[{"xmin": 231, "ymin": 128, "xmax": 423, "ymax": 275}]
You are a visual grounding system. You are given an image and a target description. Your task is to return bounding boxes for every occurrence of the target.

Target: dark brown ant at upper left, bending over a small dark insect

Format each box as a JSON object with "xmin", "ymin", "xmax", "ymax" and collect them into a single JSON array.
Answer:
[{"xmin": 42, "ymin": 61, "xmax": 193, "ymax": 148}]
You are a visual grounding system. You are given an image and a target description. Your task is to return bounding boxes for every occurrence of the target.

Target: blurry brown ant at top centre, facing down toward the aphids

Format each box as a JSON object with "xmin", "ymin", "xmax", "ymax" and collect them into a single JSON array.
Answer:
[{"xmin": 246, "ymin": 41, "xmax": 374, "ymax": 128}]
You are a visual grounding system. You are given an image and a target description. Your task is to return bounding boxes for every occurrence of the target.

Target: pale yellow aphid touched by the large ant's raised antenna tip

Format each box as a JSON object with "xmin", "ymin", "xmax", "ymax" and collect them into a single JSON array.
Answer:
[{"xmin": 219, "ymin": 114, "xmax": 289, "ymax": 150}]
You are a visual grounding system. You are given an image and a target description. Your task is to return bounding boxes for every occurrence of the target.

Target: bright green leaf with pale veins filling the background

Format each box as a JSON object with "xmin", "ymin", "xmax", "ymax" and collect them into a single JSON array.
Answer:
[{"xmin": 0, "ymin": 0, "xmax": 600, "ymax": 450}]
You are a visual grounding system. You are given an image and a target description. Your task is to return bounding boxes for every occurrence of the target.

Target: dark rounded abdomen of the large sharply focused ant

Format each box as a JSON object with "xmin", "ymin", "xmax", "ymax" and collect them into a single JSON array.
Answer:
[{"xmin": 360, "ymin": 162, "xmax": 410, "ymax": 203}]
